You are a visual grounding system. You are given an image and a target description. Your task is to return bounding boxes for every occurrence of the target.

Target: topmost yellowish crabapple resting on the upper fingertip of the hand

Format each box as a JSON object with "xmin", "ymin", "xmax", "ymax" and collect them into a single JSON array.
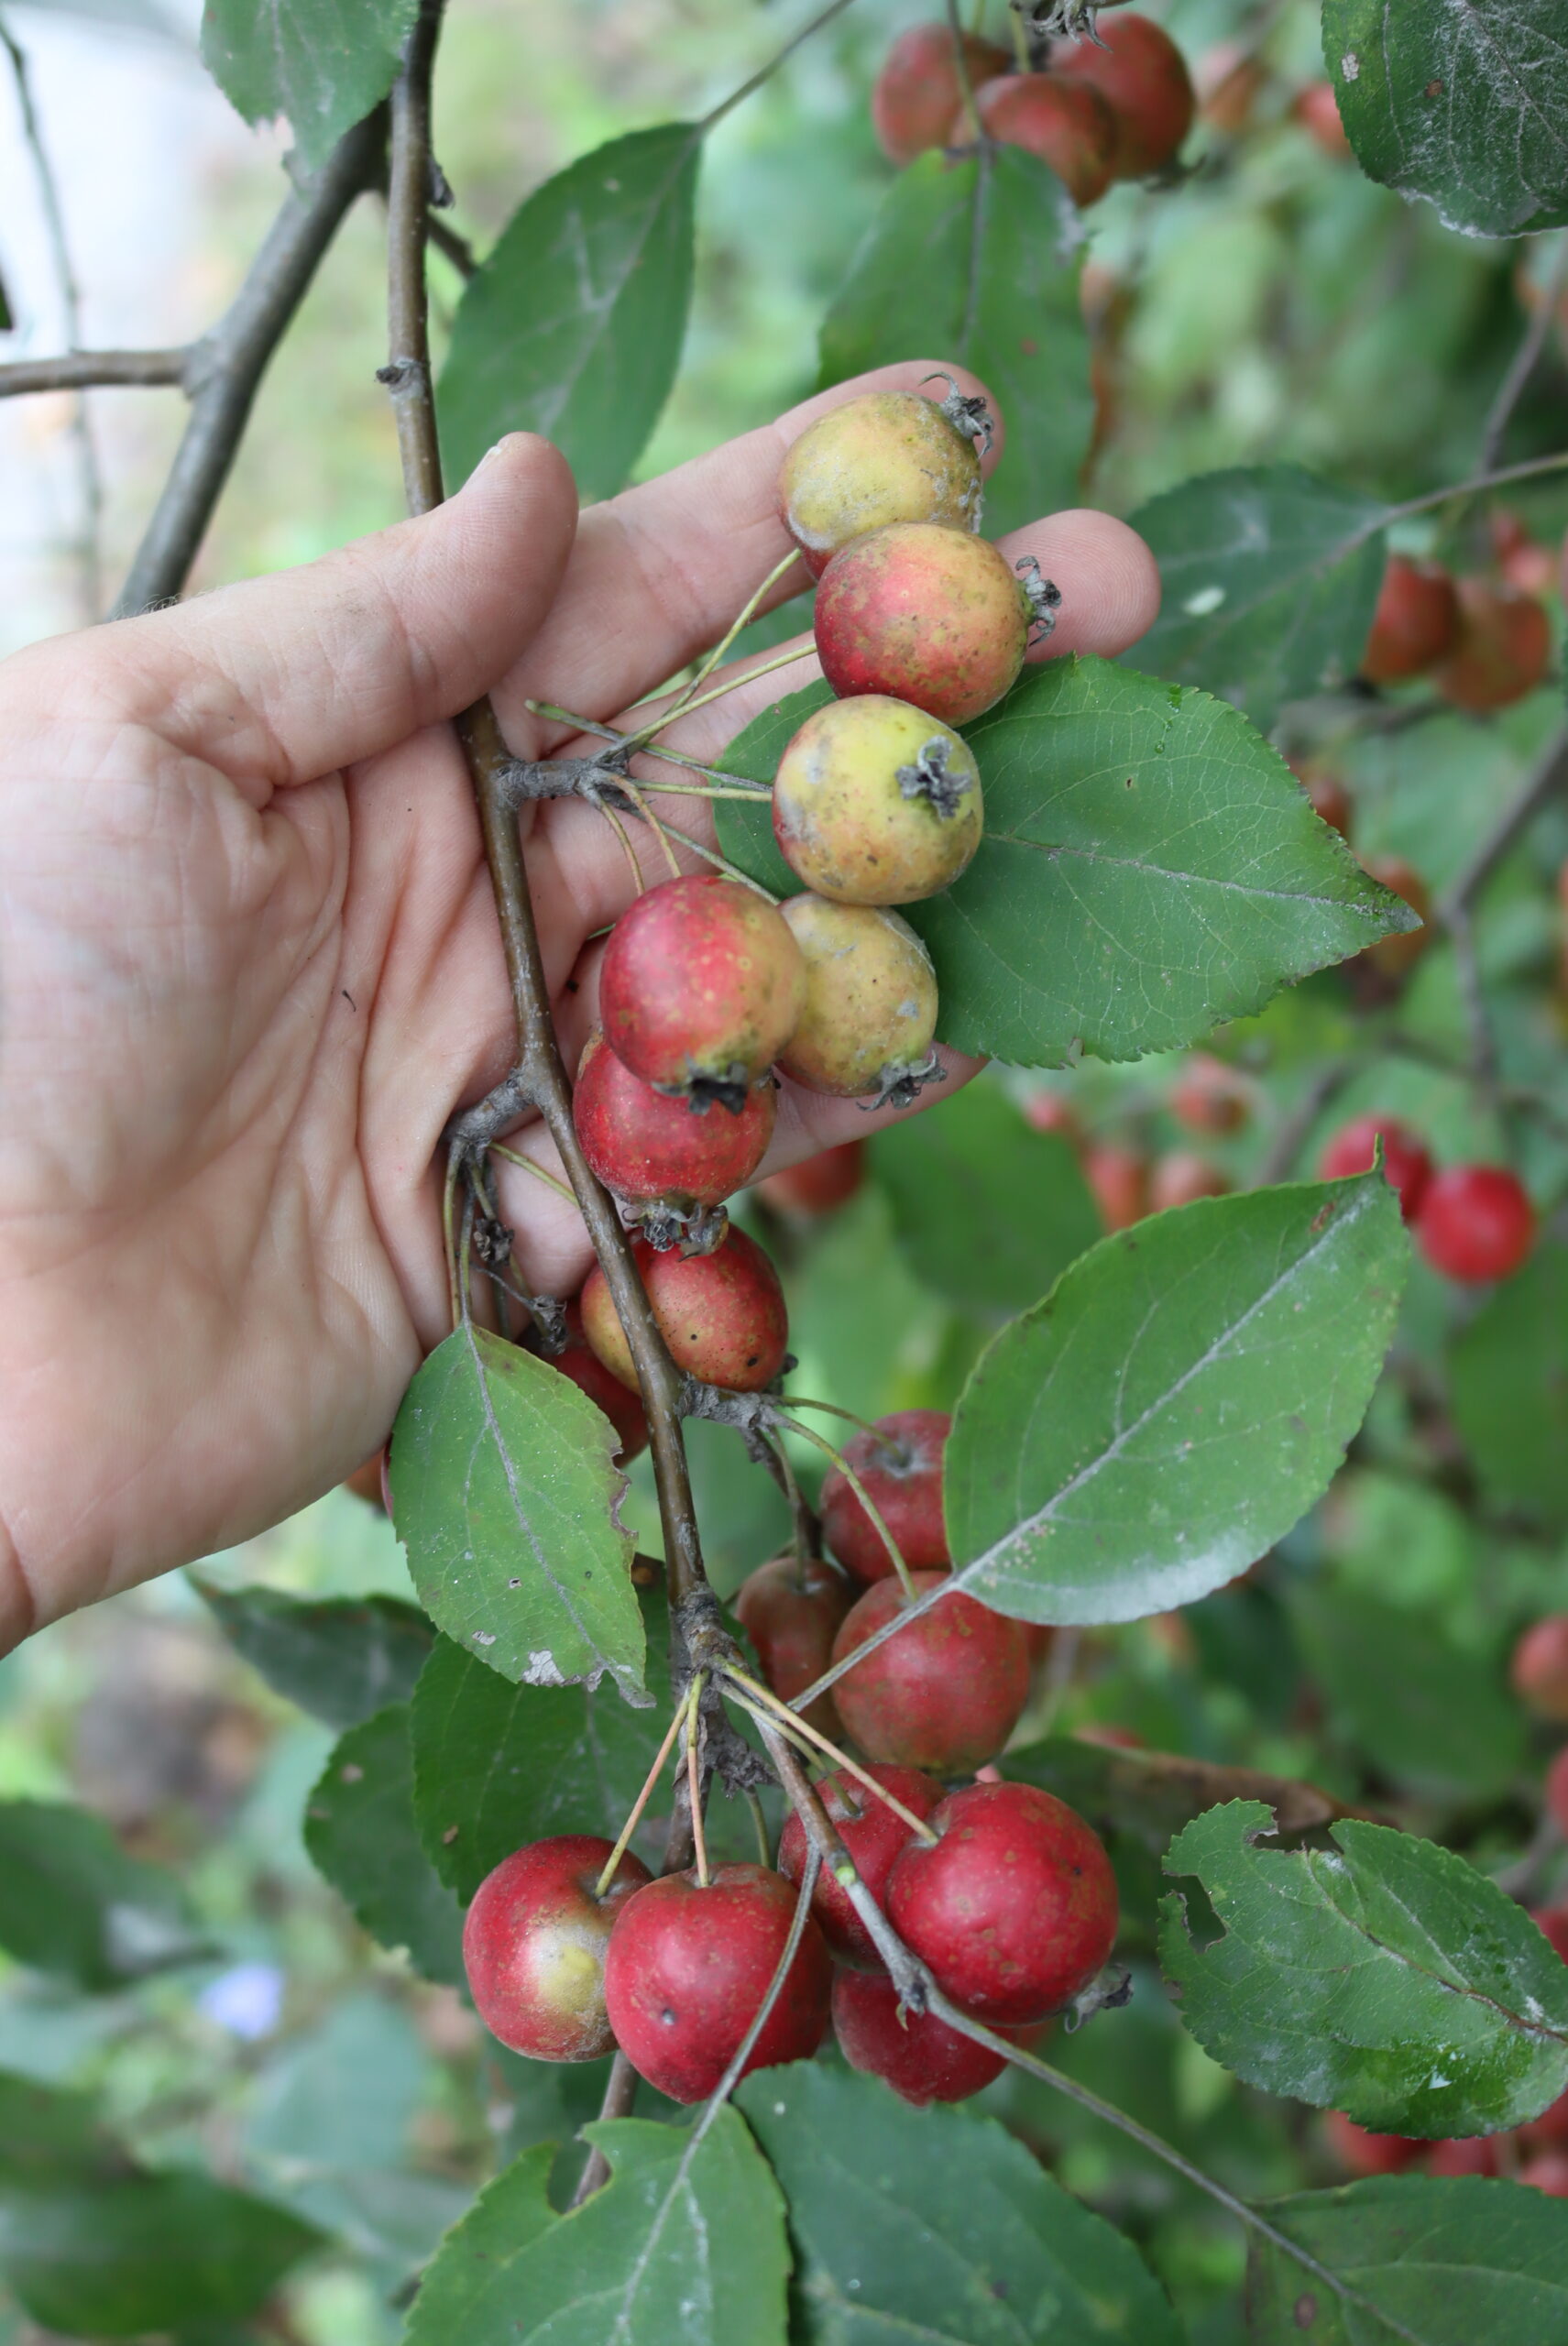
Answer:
[{"xmin": 779, "ymin": 392, "xmax": 981, "ymax": 577}]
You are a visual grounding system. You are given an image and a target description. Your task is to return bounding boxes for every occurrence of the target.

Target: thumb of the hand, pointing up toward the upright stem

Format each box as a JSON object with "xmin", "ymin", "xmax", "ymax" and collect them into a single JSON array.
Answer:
[{"xmin": 88, "ymin": 432, "xmax": 577, "ymax": 788}]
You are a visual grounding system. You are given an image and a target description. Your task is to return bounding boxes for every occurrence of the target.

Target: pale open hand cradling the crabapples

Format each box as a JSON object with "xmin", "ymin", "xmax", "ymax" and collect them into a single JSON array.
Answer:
[{"xmin": 0, "ymin": 359, "xmax": 1159, "ymax": 1650}]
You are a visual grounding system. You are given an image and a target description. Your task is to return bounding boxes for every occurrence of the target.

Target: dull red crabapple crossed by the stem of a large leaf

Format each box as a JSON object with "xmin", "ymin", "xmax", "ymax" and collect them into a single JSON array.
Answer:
[{"xmin": 833, "ymin": 1572, "xmax": 1028, "ymax": 1764}]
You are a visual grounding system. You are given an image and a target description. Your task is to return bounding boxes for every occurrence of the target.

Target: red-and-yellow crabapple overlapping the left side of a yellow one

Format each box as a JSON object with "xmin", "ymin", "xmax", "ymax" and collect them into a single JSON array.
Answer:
[{"xmin": 598, "ymin": 872, "xmax": 806, "ymax": 1105}]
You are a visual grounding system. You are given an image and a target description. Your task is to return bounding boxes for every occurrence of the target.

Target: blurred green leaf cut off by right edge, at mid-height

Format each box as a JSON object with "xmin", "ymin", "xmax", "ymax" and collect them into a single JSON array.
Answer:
[{"xmin": 1448, "ymin": 1239, "xmax": 1568, "ymax": 1525}]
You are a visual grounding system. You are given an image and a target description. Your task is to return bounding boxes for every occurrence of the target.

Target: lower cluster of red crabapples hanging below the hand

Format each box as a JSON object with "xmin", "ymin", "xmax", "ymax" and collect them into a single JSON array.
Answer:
[{"xmin": 463, "ymin": 1410, "xmax": 1117, "ymax": 2102}]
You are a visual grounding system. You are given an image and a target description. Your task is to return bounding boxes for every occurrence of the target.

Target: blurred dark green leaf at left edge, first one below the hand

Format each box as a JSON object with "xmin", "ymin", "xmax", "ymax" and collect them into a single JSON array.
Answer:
[{"xmin": 0, "ymin": 1800, "xmax": 216, "ymax": 1990}]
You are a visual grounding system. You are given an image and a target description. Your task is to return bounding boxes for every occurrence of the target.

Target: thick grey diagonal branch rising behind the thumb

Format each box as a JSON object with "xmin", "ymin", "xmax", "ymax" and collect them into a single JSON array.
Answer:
[{"xmin": 113, "ymin": 110, "xmax": 385, "ymax": 619}]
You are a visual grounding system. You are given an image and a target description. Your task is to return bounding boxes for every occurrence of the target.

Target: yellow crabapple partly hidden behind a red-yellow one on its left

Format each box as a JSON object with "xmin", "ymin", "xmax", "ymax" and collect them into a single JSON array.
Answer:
[{"xmin": 779, "ymin": 895, "xmax": 937, "ymax": 1101}]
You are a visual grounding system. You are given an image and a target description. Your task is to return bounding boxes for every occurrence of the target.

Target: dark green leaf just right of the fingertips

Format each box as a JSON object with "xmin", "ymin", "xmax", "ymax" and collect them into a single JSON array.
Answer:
[{"xmin": 1132, "ymin": 465, "xmax": 1385, "ymax": 732}]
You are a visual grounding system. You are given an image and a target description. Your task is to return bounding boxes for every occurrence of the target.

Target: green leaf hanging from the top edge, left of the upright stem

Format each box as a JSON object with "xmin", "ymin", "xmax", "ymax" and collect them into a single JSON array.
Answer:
[{"xmin": 202, "ymin": 0, "xmax": 420, "ymax": 171}]
